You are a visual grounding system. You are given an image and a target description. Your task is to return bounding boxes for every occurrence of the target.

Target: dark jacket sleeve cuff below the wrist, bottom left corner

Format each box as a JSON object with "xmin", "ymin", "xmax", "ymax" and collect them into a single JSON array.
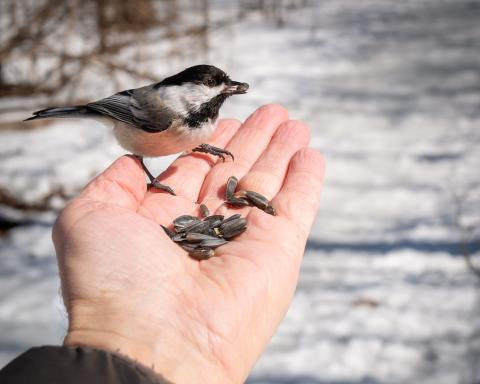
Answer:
[{"xmin": 0, "ymin": 346, "xmax": 172, "ymax": 384}]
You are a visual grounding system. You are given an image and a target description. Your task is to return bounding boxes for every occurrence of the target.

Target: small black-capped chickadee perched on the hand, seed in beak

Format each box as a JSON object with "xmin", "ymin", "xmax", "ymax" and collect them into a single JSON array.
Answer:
[{"xmin": 24, "ymin": 64, "xmax": 249, "ymax": 195}]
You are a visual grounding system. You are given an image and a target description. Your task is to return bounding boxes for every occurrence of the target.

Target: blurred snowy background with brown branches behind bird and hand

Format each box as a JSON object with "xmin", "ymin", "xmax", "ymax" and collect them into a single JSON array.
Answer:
[{"xmin": 0, "ymin": 0, "xmax": 480, "ymax": 384}]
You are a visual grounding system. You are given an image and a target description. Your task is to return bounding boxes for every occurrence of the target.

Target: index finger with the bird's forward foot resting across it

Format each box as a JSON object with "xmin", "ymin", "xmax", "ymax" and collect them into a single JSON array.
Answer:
[{"xmin": 153, "ymin": 119, "xmax": 241, "ymax": 201}]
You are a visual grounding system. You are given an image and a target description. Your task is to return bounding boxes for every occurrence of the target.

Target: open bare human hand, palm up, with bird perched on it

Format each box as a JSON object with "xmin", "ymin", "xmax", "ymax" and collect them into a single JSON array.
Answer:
[{"xmin": 53, "ymin": 105, "xmax": 323, "ymax": 383}]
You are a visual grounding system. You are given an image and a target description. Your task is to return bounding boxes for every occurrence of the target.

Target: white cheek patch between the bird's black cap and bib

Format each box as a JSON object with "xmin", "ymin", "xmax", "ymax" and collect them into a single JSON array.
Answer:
[{"xmin": 158, "ymin": 83, "xmax": 225, "ymax": 116}]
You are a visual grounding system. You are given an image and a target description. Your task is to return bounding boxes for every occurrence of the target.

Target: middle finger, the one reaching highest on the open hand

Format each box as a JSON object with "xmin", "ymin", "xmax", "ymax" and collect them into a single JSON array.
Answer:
[{"xmin": 199, "ymin": 104, "xmax": 288, "ymax": 208}]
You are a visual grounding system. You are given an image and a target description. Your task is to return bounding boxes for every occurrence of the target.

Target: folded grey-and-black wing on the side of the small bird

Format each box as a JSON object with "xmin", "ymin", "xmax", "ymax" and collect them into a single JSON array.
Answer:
[{"xmin": 87, "ymin": 89, "xmax": 174, "ymax": 132}]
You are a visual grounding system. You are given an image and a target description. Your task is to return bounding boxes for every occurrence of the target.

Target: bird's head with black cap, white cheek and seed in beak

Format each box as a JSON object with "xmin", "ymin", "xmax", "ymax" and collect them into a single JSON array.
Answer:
[{"xmin": 155, "ymin": 65, "xmax": 248, "ymax": 127}]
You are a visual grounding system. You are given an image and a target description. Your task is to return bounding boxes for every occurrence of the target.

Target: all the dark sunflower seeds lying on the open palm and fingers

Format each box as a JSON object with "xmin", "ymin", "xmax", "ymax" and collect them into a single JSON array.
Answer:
[{"xmin": 162, "ymin": 176, "xmax": 276, "ymax": 260}]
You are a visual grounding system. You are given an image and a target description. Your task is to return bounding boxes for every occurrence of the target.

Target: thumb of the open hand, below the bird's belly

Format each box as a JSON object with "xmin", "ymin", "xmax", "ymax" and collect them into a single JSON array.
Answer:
[{"xmin": 79, "ymin": 155, "xmax": 147, "ymax": 210}]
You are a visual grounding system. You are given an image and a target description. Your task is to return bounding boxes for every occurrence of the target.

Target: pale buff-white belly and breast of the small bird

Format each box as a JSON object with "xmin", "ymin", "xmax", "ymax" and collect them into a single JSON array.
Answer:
[{"xmin": 113, "ymin": 120, "xmax": 216, "ymax": 157}]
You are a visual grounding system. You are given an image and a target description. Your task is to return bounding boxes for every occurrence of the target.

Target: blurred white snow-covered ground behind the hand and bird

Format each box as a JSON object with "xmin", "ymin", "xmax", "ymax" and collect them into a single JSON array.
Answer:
[{"xmin": 0, "ymin": 0, "xmax": 480, "ymax": 384}]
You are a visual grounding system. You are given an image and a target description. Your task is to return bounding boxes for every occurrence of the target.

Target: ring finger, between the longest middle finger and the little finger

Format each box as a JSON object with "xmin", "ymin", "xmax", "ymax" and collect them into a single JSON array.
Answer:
[{"xmin": 238, "ymin": 120, "xmax": 310, "ymax": 199}]
